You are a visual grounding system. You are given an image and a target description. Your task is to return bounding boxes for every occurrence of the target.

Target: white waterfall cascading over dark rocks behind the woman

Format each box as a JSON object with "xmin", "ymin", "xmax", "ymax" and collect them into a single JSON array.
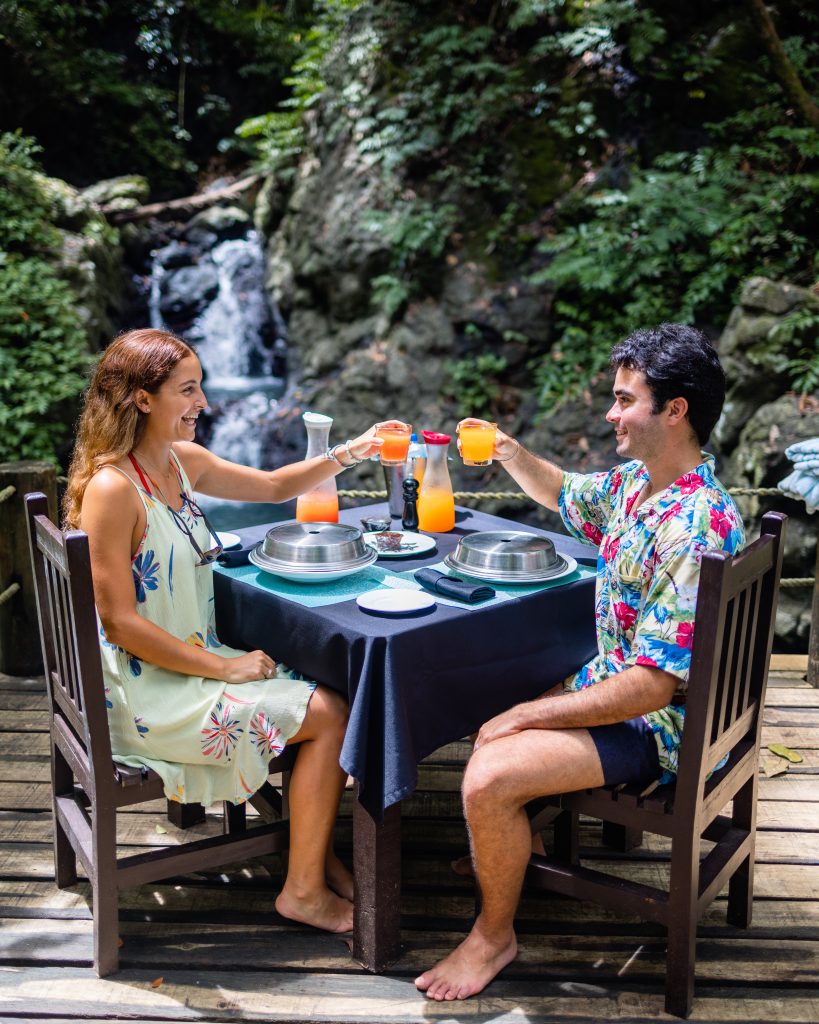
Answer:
[{"xmin": 148, "ymin": 231, "xmax": 287, "ymax": 528}]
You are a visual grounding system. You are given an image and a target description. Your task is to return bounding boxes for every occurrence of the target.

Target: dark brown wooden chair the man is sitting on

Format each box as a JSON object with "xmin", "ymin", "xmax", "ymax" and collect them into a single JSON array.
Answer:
[{"xmin": 526, "ymin": 512, "xmax": 786, "ymax": 1017}]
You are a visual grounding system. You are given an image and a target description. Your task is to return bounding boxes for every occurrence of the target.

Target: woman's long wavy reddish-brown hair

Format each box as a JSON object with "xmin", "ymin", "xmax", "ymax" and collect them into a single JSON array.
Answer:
[{"xmin": 62, "ymin": 329, "xmax": 195, "ymax": 528}]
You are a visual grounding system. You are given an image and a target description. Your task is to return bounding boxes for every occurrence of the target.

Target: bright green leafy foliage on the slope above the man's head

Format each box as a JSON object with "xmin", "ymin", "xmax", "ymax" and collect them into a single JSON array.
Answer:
[{"xmin": 534, "ymin": 117, "xmax": 819, "ymax": 407}]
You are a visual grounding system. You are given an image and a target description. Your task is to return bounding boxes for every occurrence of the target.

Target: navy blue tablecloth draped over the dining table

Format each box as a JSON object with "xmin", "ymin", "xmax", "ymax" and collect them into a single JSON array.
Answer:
[{"xmin": 214, "ymin": 505, "xmax": 596, "ymax": 821}]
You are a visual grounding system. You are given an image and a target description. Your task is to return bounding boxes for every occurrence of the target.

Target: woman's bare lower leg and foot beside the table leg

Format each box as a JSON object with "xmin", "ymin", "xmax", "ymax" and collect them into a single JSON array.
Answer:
[{"xmin": 275, "ymin": 686, "xmax": 352, "ymax": 932}]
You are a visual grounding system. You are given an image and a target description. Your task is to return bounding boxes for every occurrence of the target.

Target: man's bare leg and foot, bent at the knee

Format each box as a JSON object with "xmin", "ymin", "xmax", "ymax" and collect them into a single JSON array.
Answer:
[{"xmin": 416, "ymin": 729, "xmax": 603, "ymax": 999}]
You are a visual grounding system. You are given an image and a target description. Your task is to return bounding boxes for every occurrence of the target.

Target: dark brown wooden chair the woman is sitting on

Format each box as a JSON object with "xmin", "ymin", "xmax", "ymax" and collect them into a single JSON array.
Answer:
[{"xmin": 26, "ymin": 494, "xmax": 288, "ymax": 977}]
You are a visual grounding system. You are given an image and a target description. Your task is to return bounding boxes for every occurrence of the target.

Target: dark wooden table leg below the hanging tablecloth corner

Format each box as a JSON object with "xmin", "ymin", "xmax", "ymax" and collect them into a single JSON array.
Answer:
[{"xmin": 352, "ymin": 791, "xmax": 401, "ymax": 974}]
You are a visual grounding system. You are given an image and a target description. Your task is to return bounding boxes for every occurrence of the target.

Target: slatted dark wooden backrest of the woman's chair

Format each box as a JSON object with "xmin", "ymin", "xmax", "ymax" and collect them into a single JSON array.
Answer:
[{"xmin": 26, "ymin": 495, "xmax": 114, "ymax": 796}]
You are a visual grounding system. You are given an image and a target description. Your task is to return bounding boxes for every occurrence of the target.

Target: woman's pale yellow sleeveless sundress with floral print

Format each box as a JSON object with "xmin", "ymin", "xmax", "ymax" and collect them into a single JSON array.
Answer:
[{"xmin": 97, "ymin": 456, "xmax": 316, "ymax": 806}]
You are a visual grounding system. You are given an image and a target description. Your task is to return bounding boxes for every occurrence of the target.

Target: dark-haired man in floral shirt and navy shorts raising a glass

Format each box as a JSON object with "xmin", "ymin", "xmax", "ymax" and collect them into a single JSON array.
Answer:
[{"xmin": 416, "ymin": 324, "xmax": 744, "ymax": 999}]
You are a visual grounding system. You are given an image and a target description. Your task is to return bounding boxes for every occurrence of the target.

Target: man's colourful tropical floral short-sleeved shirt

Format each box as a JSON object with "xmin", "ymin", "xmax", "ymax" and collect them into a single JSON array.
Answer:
[{"xmin": 560, "ymin": 453, "xmax": 745, "ymax": 781}]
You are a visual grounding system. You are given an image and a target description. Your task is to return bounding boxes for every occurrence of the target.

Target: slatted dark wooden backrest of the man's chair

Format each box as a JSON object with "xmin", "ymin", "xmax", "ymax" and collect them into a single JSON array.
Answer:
[{"xmin": 676, "ymin": 512, "xmax": 786, "ymax": 813}]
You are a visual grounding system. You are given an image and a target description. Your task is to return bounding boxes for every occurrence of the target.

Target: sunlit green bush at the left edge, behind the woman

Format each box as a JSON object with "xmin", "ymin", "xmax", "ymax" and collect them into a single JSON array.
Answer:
[{"xmin": 0, "ymin": 134, "xmax": 90, "ymax": 462}]
